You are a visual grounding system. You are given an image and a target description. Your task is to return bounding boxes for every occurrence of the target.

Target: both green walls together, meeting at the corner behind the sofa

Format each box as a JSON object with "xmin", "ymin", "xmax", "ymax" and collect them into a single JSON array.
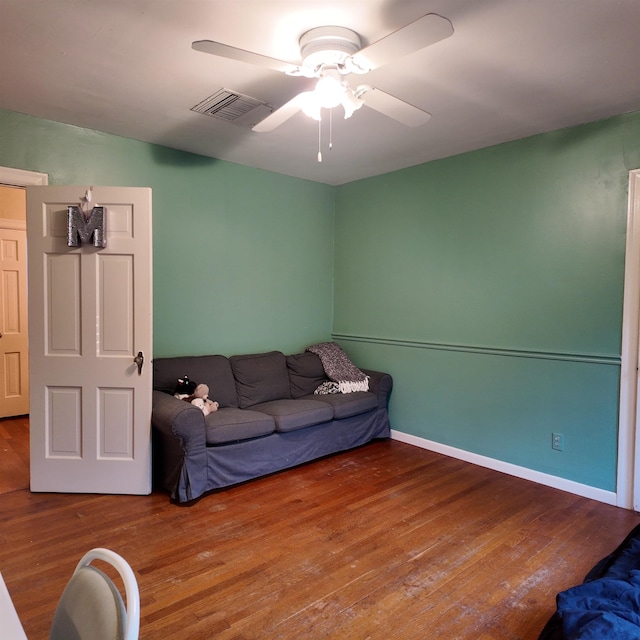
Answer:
[{"xmin": 0, "ymin": 110, "xmax": 640, "ymax": 491}]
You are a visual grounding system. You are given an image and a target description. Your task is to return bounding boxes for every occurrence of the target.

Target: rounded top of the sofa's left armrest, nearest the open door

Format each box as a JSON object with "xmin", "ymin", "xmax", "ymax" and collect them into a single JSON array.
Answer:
[{"xmin": 151, "ymin": 390, "xmax": 207, "ymax": 456}]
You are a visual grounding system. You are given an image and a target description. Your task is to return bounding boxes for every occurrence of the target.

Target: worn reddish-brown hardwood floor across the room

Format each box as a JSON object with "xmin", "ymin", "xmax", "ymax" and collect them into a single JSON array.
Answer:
[{"xmin": 0, "ymin": 421, "xmax": 640, "ymax": 640}]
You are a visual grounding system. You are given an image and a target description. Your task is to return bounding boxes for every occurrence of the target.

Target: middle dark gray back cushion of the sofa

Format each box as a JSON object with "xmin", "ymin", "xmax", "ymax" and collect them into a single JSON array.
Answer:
[{"xmin": 229, "ymin": 351, "xmax": 291, "ymax": 409}]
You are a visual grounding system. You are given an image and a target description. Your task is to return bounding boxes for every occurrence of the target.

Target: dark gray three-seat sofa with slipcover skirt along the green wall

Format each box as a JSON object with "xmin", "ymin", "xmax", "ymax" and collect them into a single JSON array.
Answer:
[{"xmin": 152, "ymin": 351, "xmax": 392, "ymax": 503}]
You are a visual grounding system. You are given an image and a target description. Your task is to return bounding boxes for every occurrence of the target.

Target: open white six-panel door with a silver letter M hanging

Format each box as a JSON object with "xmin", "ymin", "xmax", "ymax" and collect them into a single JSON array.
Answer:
[{"xmin": 27, "ymin": 186, "xmax": 152, "ymax": 494}]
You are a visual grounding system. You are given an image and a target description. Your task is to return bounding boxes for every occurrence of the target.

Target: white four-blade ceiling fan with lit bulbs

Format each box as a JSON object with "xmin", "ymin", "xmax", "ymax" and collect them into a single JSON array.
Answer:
[{"xmin": 192, "ymin": 13, "xmax": 453, "ymax": 132}]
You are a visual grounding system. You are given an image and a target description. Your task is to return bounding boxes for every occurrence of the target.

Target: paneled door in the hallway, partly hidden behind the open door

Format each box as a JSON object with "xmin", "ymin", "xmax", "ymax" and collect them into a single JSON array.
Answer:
[{"xmin": 0, "ymin": 229, "xmax": 29, "ymax": 418}]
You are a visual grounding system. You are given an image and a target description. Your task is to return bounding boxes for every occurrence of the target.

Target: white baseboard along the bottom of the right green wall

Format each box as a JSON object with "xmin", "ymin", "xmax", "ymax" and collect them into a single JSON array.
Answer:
[{"xmin": 391, "ymin": 429, "xmax": 617, "ymax": 506}]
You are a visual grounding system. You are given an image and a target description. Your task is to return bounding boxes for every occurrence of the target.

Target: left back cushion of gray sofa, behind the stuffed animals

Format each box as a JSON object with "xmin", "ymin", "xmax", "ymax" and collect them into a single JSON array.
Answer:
[{"xmin": 153, "ymin": 356, "xmax": 238, "ymax": 407}]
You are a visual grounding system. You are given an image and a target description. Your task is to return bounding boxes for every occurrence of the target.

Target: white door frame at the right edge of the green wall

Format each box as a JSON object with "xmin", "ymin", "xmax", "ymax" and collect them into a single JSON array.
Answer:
[{"xmin": 616, "ymin": 169, "xmax": 640, "ymax": 511}]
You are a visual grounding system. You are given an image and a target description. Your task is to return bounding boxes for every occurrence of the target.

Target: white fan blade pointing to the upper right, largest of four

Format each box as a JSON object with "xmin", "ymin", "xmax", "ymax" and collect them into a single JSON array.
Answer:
[{"xmin": 352, "ymin": 13, "xmax": 453, "ymax": 71}]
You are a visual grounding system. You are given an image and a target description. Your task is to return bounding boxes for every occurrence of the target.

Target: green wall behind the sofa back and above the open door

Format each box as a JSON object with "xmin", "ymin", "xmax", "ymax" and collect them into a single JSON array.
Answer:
[{"xmin": 0, "ymin": 110, "xmax": 335, "ymax": 356}]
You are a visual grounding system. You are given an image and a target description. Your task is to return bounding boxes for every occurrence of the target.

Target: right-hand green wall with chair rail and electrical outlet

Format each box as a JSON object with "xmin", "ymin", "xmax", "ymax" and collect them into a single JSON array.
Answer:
[{"xmin": 334, "ymin": 113, "xmax": 640, "ymax": 491}]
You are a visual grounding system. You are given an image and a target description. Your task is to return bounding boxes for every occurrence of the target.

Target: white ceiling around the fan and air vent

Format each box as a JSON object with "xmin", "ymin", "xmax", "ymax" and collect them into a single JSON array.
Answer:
[{"xmin": 0, "ymin": 0, "xmax": 640, "ymax": 185}]
